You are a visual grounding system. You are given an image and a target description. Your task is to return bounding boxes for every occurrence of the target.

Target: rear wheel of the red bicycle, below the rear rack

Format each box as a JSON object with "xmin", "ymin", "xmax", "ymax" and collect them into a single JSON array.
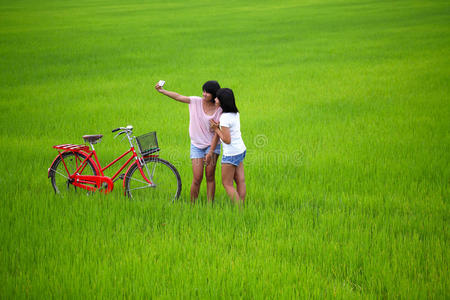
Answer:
[{"xmin": 48, "ymin": 152, "xmax": 97, "ymax": 194}]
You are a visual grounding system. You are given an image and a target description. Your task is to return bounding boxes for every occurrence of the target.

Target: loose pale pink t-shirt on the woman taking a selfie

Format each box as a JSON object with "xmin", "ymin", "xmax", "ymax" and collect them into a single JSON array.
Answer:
[{"xmin": 189, "ymin": 96, "xmax": 222, "ymax": 149}]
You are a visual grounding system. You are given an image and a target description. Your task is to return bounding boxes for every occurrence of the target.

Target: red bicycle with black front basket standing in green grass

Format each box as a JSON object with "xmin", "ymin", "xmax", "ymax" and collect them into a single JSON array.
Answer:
[{"xmin": 48, "ymin": 125, "xmax": 181, "ymax": 202}]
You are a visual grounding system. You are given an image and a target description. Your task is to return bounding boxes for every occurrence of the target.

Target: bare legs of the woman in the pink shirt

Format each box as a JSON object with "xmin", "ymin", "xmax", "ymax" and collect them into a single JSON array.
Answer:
[{"xmin": 191, "ymin": 153, "xmax": 218, "ymax": 203}]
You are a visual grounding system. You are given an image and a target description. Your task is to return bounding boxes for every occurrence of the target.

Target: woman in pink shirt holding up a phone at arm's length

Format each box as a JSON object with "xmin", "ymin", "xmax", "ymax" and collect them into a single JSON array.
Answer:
[{"xmin": 155, "ymin": 81, "xmax": 222, "ymax": 202}]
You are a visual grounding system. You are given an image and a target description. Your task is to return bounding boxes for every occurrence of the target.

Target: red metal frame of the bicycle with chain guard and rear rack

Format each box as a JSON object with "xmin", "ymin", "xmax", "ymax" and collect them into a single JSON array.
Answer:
[{"xmin": 54, "ymin": 141, "xmax": 158, "ymax": 194}]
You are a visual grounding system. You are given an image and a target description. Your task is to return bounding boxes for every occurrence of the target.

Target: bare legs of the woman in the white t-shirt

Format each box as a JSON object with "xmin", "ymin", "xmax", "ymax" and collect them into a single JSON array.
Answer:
[{"xmin": 222, "ymin": 162, "xmax": 246, "ymax": 204}]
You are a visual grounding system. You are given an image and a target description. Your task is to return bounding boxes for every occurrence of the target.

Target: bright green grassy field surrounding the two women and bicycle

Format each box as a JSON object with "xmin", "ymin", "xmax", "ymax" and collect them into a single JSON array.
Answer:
[{"xmin": 0, "ymin": 0, "xmax": 450, "ymax": 299}]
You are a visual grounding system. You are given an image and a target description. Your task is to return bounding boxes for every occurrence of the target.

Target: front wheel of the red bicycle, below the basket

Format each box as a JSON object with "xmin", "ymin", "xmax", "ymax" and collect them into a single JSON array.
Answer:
[{"xmin": 124, "ymin": 157, "xmax": 181, "ymax": 202}]
